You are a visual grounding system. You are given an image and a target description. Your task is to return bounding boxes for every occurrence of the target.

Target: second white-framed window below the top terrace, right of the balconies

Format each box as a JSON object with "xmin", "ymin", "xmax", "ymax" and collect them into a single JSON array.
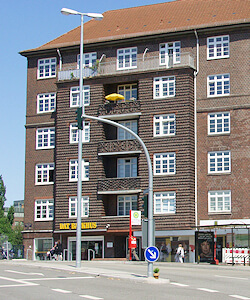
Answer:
[{"xmin": 154, "ymin": 114, "xmax": 175, "ymax": 136}]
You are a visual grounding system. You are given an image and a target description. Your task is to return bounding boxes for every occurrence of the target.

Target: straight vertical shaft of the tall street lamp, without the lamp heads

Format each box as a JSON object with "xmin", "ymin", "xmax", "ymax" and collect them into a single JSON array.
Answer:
[{"xmin": 76, "ymin": 14, "xmax": 84, "ymax": 268}]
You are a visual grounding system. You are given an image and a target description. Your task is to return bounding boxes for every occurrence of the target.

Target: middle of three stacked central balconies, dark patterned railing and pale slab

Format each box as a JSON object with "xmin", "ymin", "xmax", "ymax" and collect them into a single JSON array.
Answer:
[{"xmin": 98, "ymin": 140, "xmax": 141, "ymax": 155}]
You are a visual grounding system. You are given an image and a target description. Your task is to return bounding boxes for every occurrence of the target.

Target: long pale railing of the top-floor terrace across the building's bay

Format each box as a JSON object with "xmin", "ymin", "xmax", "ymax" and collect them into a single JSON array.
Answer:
[{"xmin": 58, "ymin": 53, "xmax": 195, "ymax": 80}]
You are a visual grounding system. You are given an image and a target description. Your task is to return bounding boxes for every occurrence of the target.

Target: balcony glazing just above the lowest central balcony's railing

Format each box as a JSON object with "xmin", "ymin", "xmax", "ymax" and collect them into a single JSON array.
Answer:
[{"xmin": 117, "ymin": 158, "xmax": 137, "ymax": 178}]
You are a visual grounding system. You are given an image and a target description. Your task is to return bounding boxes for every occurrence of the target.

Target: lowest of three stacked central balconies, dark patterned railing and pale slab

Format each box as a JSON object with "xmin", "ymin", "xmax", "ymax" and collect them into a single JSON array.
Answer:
[{"xmin": 97, "ymin": 177, "xmax": 141, "ymax": 194}]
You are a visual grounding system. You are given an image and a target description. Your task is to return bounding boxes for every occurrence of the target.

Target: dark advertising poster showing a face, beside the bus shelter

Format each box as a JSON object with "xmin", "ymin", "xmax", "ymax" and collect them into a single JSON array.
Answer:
[{"xmin": 195, "ymin": 231, "xmax": 214, "ymax": 263}]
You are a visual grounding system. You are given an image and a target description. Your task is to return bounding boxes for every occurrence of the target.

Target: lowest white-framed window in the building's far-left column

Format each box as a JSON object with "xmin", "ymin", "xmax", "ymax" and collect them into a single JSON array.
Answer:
[{"xmin": 35, "ymin": 200, "xmax": 54, "ymax": 221}]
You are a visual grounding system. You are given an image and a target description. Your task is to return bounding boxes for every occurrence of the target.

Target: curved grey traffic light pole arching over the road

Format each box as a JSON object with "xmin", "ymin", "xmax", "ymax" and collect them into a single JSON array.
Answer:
[{"xmin": 82, "ymin": 112, "xmax": 154, "ymax": 277}]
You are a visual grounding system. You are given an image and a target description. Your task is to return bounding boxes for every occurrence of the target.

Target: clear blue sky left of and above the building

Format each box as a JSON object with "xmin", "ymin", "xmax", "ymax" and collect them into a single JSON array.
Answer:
[{"xmin": 0, "ymin": 0, "xmax": 173, "ymax": 207}]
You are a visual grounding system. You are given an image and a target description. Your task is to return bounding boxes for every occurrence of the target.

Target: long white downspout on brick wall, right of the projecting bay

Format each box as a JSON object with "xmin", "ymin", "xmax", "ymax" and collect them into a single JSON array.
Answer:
[{"xmin": 194, "ymin": 30, "xmax": 200, "ymax": 227}]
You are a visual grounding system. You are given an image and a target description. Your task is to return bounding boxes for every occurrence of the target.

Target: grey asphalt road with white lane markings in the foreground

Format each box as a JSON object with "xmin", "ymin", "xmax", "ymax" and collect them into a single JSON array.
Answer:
[{"xmin": 0, "ymin": 261, "xmax": 250, "ymax": 300}]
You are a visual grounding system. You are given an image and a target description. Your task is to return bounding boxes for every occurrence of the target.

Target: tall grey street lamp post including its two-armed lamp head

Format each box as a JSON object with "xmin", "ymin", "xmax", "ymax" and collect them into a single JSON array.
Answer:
[{"xmin": 61, "ymin": 8, "xmax": 103, "ymax": 268}]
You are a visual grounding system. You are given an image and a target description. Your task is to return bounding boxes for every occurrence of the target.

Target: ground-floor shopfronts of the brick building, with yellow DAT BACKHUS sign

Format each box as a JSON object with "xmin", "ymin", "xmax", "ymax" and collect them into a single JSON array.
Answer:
[{"xmin": 24, "ymin": 220, "xmax": 250, "ymax": 263}]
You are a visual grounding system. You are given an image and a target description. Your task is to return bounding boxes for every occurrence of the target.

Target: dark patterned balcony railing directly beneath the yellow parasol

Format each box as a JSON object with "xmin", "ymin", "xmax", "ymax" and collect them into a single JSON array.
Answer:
[{"xmin": 98, "ymin": 100, "xmax": 141, "ymax": 116}]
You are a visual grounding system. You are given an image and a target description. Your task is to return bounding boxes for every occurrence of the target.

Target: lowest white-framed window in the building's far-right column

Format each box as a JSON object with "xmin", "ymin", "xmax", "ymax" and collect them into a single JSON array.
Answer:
[{"xmin": 208, "ymin": 191, "xmax": 231, "ymax": 213}]
